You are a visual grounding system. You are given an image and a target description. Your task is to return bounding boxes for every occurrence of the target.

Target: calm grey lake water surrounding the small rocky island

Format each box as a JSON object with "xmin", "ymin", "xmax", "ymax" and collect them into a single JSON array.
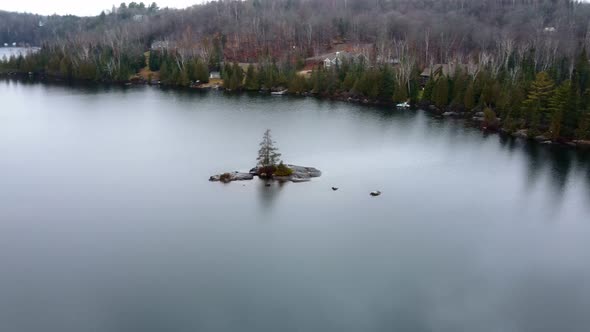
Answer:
[{"xmin": 0, "ymin": 80, "xmax": 590, "ymax": 332}]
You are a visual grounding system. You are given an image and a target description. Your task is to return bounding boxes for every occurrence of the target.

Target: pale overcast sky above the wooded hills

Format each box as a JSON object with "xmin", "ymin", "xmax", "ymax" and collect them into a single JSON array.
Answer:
[{"xmin": 0, "ymin": 0, "xmax": 202, "ymax": 16}]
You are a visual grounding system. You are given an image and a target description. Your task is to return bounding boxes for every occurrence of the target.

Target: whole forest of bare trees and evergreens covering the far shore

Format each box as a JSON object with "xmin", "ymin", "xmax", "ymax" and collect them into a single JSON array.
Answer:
[{"xmin": 0, "ymin": 0, "xmax": 590, "ymax": 141}]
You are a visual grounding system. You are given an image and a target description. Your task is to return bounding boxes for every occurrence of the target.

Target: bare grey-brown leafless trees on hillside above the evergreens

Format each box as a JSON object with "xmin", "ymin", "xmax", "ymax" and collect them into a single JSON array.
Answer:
[{"xmin": 0, "ymin": 0, "xmax": 590, "ymax": 67}]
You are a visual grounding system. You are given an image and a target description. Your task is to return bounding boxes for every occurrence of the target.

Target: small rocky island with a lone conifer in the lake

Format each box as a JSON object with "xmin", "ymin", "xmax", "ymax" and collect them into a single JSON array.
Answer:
[{"xmin": 209, "ymin": 129, "xmax": 322, "ymax": 183}]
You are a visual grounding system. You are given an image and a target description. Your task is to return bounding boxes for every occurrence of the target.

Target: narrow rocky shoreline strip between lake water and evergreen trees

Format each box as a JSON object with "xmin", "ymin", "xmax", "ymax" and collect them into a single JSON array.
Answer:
[{"xmin": 0, "ymin": 71, "xmax": 590, "ymax": 150}]
